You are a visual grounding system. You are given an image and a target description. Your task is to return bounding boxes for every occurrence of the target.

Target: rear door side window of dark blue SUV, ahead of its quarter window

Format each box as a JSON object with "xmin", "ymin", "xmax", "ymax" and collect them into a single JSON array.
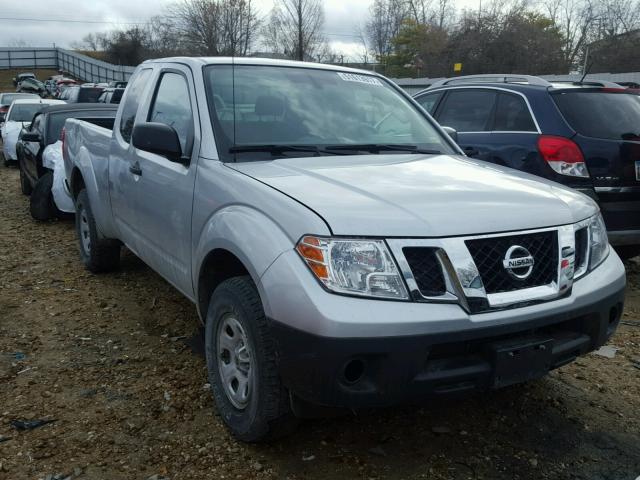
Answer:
[{"xmin": 438, "ymin": 89, "xmax": 497, "ymax": 132}]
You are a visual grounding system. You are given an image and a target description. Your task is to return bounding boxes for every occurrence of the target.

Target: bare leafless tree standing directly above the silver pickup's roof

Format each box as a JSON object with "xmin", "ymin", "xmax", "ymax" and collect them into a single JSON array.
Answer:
[{"xmin": 263, "ymin": 0, "xmax": 326, "ymax": 60}]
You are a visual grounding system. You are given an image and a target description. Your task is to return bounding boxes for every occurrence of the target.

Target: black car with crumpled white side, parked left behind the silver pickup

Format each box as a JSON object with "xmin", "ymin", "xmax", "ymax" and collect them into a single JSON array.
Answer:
[{"xmin": 16, "ymin": 103, "xmax": 117, "ymax": 220}]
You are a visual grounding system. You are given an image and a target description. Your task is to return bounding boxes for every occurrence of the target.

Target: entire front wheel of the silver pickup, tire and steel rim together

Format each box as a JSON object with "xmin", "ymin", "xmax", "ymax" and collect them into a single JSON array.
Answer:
[{"xmin": 205, "ymin": 276, "xmax": 297, "ymax": 442}]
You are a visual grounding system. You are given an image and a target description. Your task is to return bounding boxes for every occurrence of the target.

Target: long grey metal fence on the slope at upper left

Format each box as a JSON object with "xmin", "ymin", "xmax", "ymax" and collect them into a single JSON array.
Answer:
[{"xmin": 0, "ymin": 48, "xmax": 135, "ymax": 82}]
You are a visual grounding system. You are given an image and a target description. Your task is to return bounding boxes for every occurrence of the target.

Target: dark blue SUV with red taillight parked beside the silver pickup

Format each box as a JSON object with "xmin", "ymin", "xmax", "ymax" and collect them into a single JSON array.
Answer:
[{"xmin": 415, "ymin": 75, "xmax": 640, "ymax": 258}]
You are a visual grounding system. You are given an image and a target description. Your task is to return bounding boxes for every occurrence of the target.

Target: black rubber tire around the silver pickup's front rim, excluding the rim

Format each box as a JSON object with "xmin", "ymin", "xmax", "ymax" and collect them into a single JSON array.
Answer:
[{"xmin": 205, "ymin": 276, "xmax": 297, "ymax": 442}]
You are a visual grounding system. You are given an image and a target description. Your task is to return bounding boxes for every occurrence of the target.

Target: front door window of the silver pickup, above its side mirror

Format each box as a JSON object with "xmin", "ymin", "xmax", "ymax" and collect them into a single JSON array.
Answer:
[{"xmin": 149, "ymin": 72, "xmax": 193, "ymax": 154}]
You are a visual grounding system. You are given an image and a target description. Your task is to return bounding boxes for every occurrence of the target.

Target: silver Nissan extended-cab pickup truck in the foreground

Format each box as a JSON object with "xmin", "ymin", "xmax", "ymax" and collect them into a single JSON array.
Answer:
[{"xmin": 63, "ymin": 58, "xmax": 625, "ymax": 441}]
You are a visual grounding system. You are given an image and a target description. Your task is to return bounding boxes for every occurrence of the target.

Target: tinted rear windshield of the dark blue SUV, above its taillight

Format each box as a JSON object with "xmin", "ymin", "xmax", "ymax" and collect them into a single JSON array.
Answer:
[{"xmin": 553, "ymin": 91, "xmax": 640, "ymax": 140}]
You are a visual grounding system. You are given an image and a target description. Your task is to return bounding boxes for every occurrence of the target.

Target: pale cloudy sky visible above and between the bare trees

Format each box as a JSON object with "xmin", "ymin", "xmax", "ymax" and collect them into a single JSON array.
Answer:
[{"xmin": 0, "ymin": 0, "xmax": 475, "ymax": 58}]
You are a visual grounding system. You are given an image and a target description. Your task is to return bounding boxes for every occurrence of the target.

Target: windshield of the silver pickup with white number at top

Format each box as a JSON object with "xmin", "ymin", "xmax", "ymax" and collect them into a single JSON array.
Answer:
[{"xmin": 205, "ymin": 65, "xmax": 457, "ymax": 161}]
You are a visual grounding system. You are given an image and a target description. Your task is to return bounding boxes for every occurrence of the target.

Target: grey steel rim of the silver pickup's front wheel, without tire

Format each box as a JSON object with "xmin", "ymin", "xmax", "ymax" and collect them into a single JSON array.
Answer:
[{"xmin": 216, "ymin": 314, "xmax": 254, "ymax": 410}]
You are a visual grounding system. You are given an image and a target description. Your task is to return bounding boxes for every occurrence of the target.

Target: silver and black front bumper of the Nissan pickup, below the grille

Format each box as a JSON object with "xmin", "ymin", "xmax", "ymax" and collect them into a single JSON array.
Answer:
[{"xmin": 259, "ymin": 250, "xmax": 625, "ymax": 408}]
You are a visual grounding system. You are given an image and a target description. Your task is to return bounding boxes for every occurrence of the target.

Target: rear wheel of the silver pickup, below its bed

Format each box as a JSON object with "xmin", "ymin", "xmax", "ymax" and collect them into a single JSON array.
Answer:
[{"xmin": 76, "ymin": 189, "xmax": 120, "ymax": 273}]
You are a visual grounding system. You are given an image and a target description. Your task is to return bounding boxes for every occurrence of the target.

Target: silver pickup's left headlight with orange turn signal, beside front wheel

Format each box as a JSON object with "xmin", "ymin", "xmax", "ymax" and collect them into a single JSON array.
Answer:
[{"xmin": 296, "ymin": 236, "xmax": 409, "ymax": 300}]
